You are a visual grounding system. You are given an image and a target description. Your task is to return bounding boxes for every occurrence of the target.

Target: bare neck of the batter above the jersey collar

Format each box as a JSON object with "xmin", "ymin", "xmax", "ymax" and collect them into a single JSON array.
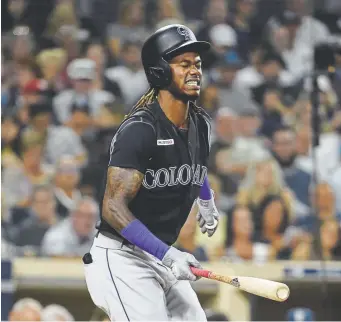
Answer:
[{"xmin": 158, "ymin": 91, "xmax": 189, "ymax": 127}]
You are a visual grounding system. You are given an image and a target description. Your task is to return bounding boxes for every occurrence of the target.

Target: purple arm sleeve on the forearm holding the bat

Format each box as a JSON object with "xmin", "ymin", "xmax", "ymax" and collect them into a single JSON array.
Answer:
[{"xmin": 121, "ymin": 219, "xmax": 170, "ymax": 260}]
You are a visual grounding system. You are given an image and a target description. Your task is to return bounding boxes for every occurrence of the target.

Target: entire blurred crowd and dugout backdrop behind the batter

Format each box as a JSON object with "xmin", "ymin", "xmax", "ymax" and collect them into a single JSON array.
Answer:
[{"xmin": 1, "ymin": 0, "xmax": 341, "ymax": 321}]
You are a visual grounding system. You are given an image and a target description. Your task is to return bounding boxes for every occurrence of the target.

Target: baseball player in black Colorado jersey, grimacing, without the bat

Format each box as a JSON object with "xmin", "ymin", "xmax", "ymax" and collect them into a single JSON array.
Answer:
[{"xmin": 83, "ymin": 25, "xmax": 218, "ymax": 321}]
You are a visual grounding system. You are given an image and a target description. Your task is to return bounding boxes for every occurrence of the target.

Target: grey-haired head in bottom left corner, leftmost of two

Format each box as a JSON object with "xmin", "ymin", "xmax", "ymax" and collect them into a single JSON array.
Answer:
[{"xmin": 9, "ymin": 297, "xmax": 43, "ymax": 322}]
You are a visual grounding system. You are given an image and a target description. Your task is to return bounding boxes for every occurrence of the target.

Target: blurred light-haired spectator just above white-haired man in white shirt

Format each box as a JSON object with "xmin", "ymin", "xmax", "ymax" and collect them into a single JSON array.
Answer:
[{"xmin": 54, "ymin": 156, "xmax": 81, "ymax": 218}]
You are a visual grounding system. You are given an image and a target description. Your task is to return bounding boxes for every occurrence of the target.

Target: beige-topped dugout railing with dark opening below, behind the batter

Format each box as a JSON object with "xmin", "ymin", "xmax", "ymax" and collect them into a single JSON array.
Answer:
[{"xmin": 2, "ymin": 258, "xmax": 341, "ymax": 321}]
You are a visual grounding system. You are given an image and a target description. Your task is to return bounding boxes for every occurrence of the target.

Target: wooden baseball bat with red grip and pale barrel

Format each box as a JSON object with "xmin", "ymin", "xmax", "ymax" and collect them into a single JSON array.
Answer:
[{"xmin": 191, "ymin": 267, "xmax": 290, "ymax": 302}]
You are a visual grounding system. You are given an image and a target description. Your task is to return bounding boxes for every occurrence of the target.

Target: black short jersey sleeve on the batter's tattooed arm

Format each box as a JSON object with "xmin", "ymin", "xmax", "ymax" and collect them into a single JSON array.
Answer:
[{"xmin": 109, "ymin": 119, "xmax": 156, "ymax": 173}]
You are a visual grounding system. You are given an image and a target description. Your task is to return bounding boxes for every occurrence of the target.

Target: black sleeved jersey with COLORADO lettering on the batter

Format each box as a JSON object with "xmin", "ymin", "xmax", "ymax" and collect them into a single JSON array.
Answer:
[{"xmin": 100, "ymin": 101, "xmax": 210, "ymax": 245}]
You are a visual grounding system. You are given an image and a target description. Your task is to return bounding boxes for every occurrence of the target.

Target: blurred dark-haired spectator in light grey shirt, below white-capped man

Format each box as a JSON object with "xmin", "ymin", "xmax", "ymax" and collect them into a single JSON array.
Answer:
[{"xmin": 25, "ymin": 101, "xmax": 87, "ymax": 165}]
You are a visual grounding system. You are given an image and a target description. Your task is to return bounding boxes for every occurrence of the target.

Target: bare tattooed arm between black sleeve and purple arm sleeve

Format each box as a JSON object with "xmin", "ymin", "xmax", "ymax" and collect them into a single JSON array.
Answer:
[{"xmin": 102, "ymin": 167, "xmax": 144, "ymax": 232}]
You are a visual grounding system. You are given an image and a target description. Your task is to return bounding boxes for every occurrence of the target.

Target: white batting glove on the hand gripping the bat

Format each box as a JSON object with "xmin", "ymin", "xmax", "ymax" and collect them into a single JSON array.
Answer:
[{"xmin": 162, "ymin": 247, "xmax": 202, "ymax": 281}]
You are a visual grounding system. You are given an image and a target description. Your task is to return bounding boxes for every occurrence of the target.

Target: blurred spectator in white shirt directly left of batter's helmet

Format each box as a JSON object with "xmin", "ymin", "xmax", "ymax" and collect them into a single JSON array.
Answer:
[{"xmin": 105, "ymin": 40, "xmax": 148, "ymax": 109}]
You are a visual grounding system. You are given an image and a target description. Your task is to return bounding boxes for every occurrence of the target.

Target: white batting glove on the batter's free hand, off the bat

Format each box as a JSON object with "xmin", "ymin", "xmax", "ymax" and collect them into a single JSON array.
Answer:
[{"xmin": 197, "ymin": 190, "xmax": 219, "ymax": 237}]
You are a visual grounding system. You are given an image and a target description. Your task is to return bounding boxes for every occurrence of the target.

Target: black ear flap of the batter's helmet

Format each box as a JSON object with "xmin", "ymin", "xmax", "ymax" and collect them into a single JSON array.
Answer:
[{"xmin": 147, "ymin": 58, "xmax": 172, "ymax": 89}]
